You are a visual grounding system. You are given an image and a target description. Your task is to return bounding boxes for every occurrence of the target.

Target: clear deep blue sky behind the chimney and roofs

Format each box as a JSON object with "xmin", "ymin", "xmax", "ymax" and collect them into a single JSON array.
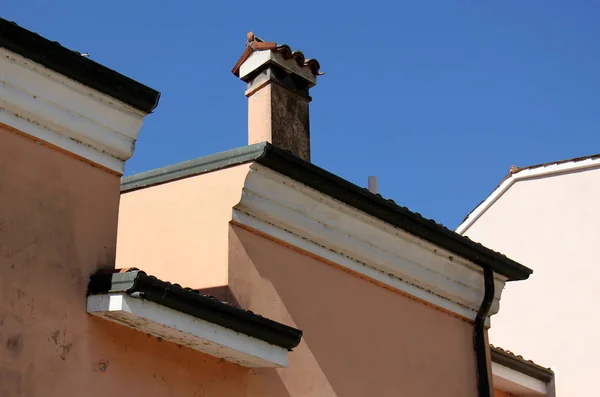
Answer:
[{"xmin": 2, "ymin": 0, "xmax": 600, "ymax": 228}]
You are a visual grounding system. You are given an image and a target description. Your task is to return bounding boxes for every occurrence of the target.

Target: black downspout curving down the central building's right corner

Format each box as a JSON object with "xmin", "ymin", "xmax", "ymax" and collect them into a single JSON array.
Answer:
[{"xmin": 473, "ymin": 266, "xmax": 495, "ymax": 397}]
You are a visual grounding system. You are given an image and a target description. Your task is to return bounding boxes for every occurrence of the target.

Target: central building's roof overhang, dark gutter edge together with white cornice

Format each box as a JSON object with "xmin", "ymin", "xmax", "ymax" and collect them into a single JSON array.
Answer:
[{"xmin": 121, "ymin": 143, "xmax": 530, "ymax": 321}]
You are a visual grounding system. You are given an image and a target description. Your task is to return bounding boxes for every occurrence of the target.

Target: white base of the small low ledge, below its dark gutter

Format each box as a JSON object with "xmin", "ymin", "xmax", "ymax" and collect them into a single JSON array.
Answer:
[{"xmin": 87, "ymin": 293, "xmax": 288, "ymax": 368}]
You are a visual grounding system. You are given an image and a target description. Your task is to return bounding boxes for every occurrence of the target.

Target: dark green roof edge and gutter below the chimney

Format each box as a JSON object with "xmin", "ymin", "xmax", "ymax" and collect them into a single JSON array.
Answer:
[{"xmin": 121, "ymin": 142, "xmax": 532, "ymax": 280}]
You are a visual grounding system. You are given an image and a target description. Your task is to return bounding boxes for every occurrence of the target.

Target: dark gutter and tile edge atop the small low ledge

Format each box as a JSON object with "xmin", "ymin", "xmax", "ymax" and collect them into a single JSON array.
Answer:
[{"xmin": 88, "ymin": 268, "xmax": 302, "ymax": 350}]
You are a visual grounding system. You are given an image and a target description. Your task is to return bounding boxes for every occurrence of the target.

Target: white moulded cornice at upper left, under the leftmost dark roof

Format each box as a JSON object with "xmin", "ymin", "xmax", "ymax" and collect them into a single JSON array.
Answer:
[{"xmin": 0, "ymin": 48, "xmax": 144, "ymax": 174}]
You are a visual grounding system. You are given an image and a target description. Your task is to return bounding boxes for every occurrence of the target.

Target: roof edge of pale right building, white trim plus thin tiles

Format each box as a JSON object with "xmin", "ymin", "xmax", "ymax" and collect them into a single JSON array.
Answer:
[{"xmin": 456, "ymin": 153, "xmax": 600, "ymax": 234}]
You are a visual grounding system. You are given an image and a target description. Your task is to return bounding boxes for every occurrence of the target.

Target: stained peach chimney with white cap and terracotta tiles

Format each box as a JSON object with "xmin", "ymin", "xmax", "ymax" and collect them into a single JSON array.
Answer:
[{"xmin": 232, "ymin": 32, "xmax": 322, "ymax": 161}]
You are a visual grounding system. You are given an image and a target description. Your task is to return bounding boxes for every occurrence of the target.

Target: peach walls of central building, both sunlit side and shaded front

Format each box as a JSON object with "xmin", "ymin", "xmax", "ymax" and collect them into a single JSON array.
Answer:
[{"xmin": 117, "ymin": 165, "xmax": 492, "ymax": 397}]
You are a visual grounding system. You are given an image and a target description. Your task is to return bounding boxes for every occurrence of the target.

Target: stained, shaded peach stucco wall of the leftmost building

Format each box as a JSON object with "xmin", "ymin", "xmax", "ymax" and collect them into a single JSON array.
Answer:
[{"xmin": 0, "ymin": 127, "xmax": 249, "ymax": 397}]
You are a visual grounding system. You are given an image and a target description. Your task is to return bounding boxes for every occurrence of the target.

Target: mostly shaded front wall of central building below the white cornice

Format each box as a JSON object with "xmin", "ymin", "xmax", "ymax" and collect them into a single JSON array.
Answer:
[{"xmin": 229, "ymin": 226, "xmax": 477, "ymax": 397}]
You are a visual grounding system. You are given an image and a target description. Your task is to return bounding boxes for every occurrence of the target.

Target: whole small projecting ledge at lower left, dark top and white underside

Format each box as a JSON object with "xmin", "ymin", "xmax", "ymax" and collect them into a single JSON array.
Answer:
[{"xmin": 87, "ymin": 272, "xmax": 302, "ymax": 367}]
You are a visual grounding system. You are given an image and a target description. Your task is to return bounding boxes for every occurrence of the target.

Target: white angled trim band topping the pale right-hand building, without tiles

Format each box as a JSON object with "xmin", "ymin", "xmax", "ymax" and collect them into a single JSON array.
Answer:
[{"xmin": 456, "ymin": 158, "xmax": 600, "ymax": 234}]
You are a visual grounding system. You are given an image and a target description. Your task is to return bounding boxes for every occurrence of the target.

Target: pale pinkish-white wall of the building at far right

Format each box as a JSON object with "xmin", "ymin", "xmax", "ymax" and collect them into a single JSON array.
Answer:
[{"xmin": 466, "ymin": 169, "xmax": 600, "ymax": 397}]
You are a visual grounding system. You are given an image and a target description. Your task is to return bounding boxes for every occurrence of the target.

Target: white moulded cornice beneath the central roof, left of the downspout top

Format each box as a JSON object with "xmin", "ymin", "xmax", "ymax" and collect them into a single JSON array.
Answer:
[{"xmin": 233, "ymin": 164, "xmax": 506, "ymax": 320}]
